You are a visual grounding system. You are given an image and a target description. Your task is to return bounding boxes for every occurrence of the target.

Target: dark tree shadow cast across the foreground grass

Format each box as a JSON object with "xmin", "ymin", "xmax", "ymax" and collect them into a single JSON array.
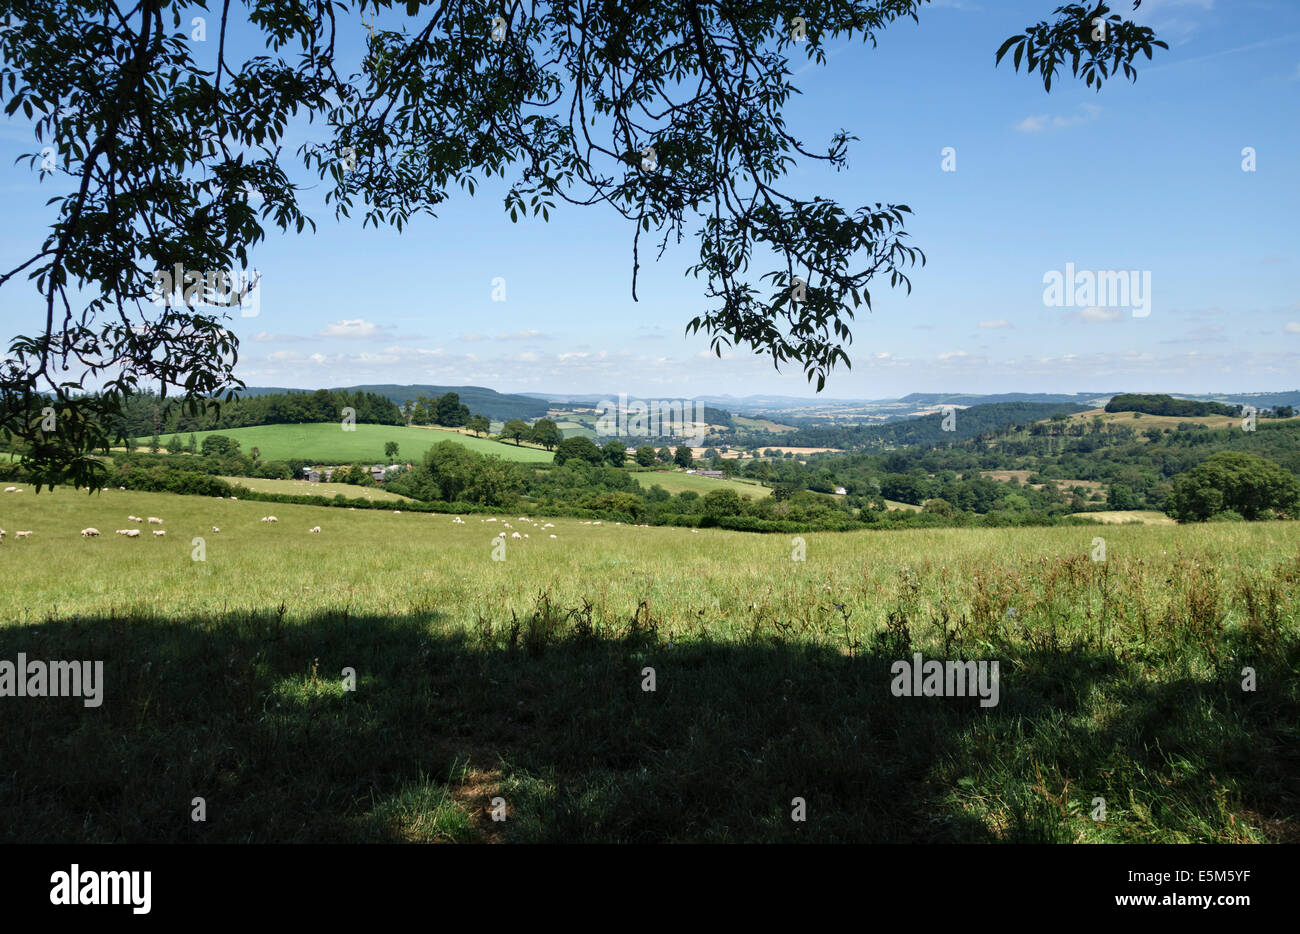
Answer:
[{"xmin": 0, "ymin": 611, "xmax": 1300, "ymax": 843}]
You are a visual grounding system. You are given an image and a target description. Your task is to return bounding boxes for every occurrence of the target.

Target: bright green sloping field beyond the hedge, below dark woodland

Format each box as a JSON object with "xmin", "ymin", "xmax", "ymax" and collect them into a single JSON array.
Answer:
[{"xmin": 135, "ymin": 421, "xmax": 554, "ymax": 464}]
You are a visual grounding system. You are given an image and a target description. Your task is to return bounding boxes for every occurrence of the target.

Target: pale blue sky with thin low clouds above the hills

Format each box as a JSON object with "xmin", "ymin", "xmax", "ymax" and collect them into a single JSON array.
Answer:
[{"xmin": 0, "ymin": 0, "xmax": 1300, "ymax": 398}]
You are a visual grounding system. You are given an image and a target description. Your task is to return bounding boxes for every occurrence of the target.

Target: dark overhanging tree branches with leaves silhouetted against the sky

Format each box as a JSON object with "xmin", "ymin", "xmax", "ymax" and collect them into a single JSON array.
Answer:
[{"xmin": 0, "ymin": 0, "xmax": 1165, "ymax": 489}]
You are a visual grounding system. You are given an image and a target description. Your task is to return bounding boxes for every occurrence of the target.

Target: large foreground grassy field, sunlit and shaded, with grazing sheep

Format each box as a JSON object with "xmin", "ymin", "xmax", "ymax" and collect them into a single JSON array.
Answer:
[{"xmin": 0, "ymin": 490, "xmax": 1300, "ymax": 843}]
